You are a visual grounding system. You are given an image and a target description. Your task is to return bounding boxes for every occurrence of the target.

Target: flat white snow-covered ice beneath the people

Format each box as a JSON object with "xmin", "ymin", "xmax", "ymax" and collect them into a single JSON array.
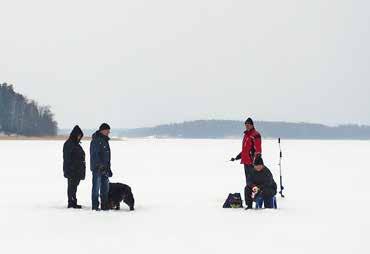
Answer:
[{"xmin": 0, "ymin": 140, "xmax": 370, "ymax": 254}]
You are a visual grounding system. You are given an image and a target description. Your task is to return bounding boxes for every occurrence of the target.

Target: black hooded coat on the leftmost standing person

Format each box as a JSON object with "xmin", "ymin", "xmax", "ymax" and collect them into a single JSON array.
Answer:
[{"xmin": 63, "ymin": 125, "xmax": 86, "ymax": 180}]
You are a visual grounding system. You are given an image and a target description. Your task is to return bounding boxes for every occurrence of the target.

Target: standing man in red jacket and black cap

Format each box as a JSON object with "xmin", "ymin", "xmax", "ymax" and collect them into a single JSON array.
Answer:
[{"xmin": 231, "ymin": 118, "xmax": 262, "ymax": 184}]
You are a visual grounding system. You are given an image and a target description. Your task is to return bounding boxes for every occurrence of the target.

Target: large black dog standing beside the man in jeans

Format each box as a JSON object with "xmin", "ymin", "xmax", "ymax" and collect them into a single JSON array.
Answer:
[{"xmin": 109, "ymin": 183, "xmax": 135, "ymax": 211}]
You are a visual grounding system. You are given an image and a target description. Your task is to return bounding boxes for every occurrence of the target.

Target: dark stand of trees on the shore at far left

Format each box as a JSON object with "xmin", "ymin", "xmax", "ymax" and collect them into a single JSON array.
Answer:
[{"xmin": 0, "ymin": 83, "xmax": 58, "ymax": 136}]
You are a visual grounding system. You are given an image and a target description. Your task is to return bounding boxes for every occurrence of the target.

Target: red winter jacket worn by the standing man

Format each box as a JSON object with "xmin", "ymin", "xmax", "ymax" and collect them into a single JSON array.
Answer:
[{"xmin": 236, "ymin": 129, "xmax": 262, "ymax": 165}]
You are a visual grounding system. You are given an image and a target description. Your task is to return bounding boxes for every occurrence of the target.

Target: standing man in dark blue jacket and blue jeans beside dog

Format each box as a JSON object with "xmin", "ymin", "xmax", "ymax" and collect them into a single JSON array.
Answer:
[{"xmin": 90, "ymin": 123, "xmax": 113, "ymax": 211}]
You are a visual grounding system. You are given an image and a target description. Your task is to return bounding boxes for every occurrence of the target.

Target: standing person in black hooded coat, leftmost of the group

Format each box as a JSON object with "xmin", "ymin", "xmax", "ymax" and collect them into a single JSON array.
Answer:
[{"xmin": 63, "ymin": 125, "xmax": 86, "ymax": 209}]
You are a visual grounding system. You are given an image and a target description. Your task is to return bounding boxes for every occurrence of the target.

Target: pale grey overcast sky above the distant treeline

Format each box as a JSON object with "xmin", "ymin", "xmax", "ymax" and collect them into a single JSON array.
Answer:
[{"xmin": 0, "ymin": 0, "xmax": 370, "ymax": 128}]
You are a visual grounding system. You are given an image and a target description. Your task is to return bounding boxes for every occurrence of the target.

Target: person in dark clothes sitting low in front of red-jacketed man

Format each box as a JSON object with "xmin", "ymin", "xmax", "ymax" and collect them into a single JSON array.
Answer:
[{"xmin": 244, "ymin": 157, "xmax": 277, "ymax": 210}]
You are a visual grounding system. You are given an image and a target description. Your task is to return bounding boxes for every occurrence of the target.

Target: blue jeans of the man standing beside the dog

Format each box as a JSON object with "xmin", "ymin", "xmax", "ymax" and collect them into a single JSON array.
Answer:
[{"xmin": 91, "ymin": 172, "xmax": 109, "ymax": 209}]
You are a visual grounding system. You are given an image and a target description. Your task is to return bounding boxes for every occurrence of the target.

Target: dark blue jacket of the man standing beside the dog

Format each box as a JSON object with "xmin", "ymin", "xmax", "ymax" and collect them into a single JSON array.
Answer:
[{"xmin": 90, "ymin": 131, "xmax": 111, "ymax": 174}]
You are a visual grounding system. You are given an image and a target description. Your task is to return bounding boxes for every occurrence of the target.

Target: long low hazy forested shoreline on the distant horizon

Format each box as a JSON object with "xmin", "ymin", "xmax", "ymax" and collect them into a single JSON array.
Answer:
[{"xmin": 115, "ymin": 120, "xmax": 370, "ymax": 139}]
